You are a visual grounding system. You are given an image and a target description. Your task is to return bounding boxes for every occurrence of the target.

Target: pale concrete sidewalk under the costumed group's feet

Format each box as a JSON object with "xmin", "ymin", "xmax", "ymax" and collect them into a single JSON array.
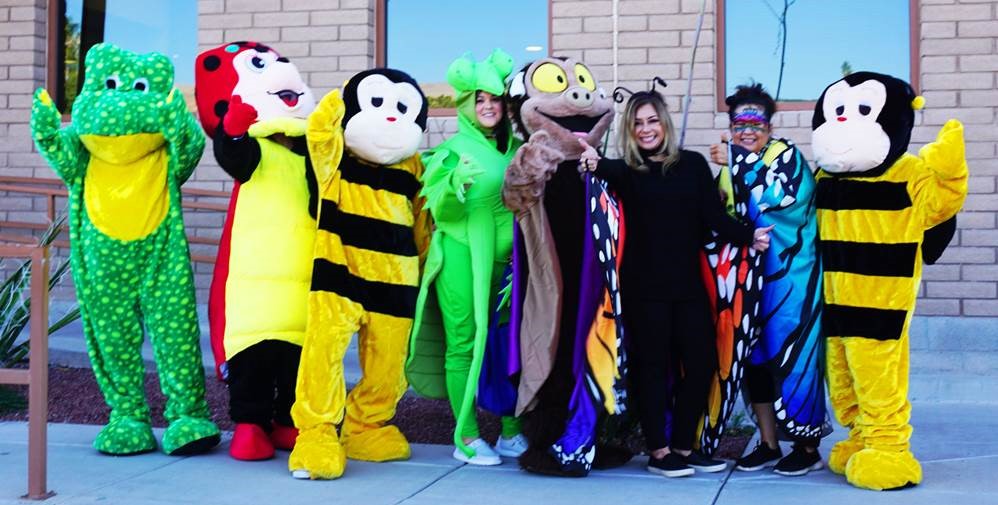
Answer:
[{"xmin": 0, "ymin": 403, "xmax": 998, "ymax": 505}]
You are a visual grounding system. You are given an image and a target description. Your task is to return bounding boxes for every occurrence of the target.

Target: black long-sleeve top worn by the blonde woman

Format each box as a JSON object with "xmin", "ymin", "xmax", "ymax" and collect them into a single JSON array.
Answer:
[{"xmin": 596, "ymin": 151, "xmax": 753, "ymax": 300}]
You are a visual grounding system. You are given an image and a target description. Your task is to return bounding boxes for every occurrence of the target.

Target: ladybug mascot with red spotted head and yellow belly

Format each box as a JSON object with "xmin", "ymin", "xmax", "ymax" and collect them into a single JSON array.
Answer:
[{"xmin": 194, "ymin": 42, "xmax": 316, "ymax": 460}]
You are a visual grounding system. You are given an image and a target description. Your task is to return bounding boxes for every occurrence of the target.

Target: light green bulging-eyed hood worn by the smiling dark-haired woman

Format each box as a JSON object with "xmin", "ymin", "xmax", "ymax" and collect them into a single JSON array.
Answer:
[{"xmin": 447, "ymin": 49, "xmax": 513, "ymax": 152}]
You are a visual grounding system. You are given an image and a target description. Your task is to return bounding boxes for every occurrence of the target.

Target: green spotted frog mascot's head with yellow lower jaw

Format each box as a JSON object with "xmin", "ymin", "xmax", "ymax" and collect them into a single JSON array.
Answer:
[{"xmin": 71, "ymin": 43, "xmax": 183, "ymax": 163}]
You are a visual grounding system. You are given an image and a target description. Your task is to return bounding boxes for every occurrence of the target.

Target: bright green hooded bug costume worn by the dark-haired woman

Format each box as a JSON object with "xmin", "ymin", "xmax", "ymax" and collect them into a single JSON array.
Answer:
[{"xmin": 406, "ymin": 49, "xmax": 519, "ymax": 456}]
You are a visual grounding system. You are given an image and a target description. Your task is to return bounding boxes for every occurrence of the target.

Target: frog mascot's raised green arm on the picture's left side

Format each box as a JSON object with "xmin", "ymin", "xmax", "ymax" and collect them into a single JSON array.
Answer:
[{"xmin": 31, "ymin": 88, "xmax": 84, "ymax": 185}]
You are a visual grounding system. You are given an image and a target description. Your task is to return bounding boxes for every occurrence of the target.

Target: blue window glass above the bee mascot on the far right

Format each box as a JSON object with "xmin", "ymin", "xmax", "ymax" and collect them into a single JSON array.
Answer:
[{"xmin": 725, "ymin": 0, "xmax": 911, "ymax": 100}]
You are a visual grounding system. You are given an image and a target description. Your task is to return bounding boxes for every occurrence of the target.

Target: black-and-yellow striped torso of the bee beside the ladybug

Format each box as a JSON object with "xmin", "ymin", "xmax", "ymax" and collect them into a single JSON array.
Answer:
[{"xmin": 311, "ymin": 153, "xmax": 420, "ymax": 319}]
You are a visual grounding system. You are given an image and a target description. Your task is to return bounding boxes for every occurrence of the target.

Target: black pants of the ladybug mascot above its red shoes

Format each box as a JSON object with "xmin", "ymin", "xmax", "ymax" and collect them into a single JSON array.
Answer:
[{"xmin": 229, "ymin": 340, "xmax": 301, "ymax": 432}]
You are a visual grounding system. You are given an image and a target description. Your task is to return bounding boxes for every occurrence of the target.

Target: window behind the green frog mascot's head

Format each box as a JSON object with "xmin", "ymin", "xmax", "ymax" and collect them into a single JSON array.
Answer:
[{"xmin": 49, "ymin": 0, "xmax": 198, "ymax": 113}]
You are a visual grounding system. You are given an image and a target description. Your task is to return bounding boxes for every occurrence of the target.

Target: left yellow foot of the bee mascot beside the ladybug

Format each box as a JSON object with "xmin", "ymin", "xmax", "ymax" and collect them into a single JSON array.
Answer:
[{"xmin": 288, "ymin": 425, "xmax": 347, "ymax": 480}]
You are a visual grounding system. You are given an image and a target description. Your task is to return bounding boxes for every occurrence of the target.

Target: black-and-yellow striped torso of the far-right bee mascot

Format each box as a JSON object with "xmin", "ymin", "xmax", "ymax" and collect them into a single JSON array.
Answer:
[{"xmin": 816, "ymin": 155, "xmax": 925, "ymax": 340}]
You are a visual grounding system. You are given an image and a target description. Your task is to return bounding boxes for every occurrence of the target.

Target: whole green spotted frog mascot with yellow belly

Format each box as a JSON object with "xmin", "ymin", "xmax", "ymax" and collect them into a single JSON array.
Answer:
[{"xmin": 31, "ymin": 44, "xmax": 220, "ymax": 455}]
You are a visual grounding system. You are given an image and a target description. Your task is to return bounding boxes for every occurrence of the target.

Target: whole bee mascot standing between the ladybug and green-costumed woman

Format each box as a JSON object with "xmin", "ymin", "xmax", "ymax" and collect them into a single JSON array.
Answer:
[{"xmin": 288, "ymin": 68, "xmax": 430, "ymax": 479}]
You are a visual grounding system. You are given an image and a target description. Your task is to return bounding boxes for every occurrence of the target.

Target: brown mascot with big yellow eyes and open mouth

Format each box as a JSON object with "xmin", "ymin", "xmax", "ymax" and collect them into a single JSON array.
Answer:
[{"xmin": 503, "ymin": 58, "xmax": 630, "ymax": 476}]
